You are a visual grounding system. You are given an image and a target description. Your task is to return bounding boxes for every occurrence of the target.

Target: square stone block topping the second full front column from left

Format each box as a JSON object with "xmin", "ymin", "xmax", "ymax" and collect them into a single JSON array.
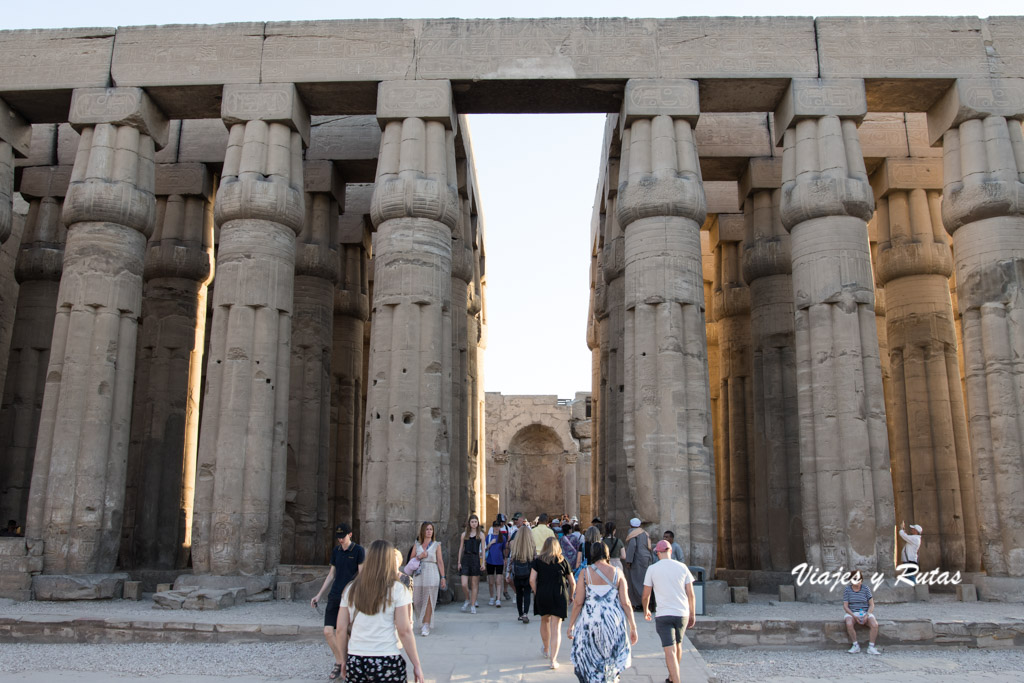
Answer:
[{"xmin": 220, "ymin": 83, "xmax": 309, "ymax": 146}]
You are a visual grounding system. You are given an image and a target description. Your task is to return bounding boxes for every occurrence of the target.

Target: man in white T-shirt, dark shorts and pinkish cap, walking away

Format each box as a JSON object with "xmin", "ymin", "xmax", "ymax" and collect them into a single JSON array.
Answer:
[{"xmin": 641, "ymin": 540, "xmax": 696, "ymax": 683}]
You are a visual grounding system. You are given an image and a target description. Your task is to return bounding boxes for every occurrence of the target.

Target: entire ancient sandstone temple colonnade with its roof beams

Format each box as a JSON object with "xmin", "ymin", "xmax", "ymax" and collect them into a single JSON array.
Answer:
[{"xmin": 0, "ymin": 17, "xmax": 1024, "ymax": 598}]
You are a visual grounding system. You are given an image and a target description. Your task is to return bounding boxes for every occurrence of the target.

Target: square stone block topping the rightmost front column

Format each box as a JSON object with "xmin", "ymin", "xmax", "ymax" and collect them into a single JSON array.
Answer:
[{"xmin": 928, "ymin": 78, "xmax": 1024, "ymax": 145}]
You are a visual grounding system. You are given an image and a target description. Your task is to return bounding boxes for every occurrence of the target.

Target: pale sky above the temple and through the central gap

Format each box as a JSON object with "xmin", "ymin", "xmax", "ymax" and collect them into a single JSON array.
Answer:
[{"xmin": 6, "ymin": 0, "xmax": 1024, "ymax": 397}]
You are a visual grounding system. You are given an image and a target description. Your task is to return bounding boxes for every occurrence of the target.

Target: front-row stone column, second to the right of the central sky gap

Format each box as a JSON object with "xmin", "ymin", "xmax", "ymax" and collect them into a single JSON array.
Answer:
[{"xmin": 775, "ymin": 79, "xmax": 894, "ymax": 573}]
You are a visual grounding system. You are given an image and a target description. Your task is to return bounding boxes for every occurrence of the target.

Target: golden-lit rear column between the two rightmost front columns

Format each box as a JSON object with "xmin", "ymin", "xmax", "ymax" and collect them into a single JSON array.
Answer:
[{"xmin": 871, "ymin": 159, "xmax": 981, "ymax": 571}]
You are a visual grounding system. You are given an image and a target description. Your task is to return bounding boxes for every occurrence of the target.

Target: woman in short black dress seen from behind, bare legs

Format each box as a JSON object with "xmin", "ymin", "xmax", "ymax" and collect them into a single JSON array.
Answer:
[{"xmin": 529, "ymin": 537, "xmax": 575, "ymax": 669}]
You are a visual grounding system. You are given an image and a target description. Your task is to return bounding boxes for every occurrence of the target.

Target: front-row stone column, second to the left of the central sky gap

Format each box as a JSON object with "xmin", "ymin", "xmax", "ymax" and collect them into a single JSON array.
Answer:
[{"xmin": 193, "ymin": 84, "xmax": 309, "ymax": 575}]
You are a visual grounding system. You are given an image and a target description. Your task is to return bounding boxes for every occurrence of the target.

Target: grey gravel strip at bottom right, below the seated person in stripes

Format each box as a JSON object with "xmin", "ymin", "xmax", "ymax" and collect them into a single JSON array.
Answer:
[{"xmin": 700, "ymin": 645, "xmax": 1024, "ymax": 683}]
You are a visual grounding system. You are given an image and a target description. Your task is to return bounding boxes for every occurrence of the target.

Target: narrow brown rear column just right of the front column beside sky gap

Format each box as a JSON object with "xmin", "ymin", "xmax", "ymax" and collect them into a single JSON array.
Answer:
[{"xmin": 710, "ymin": 214, "xmax": 762, "ymax": 569}]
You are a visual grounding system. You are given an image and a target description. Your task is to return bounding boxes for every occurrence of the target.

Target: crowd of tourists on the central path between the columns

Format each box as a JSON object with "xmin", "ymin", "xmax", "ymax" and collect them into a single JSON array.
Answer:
[{"xmin": 310, "ymin": 513, "xmax": 694, "ymax": 683}]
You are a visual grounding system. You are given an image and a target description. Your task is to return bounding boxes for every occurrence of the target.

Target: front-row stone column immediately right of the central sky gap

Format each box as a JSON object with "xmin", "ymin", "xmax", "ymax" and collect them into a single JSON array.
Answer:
[{"xmin": 615, "ymin": 80, "xmax": 716, "ymax": 568}]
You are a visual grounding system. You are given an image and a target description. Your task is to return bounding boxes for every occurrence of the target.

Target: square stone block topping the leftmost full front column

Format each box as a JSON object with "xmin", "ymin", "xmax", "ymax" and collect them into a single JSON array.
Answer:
[{"xmin": 68, "ymin": 88, "xmax": 169, "ymax": 148}]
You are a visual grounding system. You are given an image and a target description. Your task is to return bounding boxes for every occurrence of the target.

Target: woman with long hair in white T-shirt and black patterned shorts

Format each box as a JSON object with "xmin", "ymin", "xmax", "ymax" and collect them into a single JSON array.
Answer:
[{"xmin": 335, "ymin": 541, "xmax": 424, "ymax": 683}]
